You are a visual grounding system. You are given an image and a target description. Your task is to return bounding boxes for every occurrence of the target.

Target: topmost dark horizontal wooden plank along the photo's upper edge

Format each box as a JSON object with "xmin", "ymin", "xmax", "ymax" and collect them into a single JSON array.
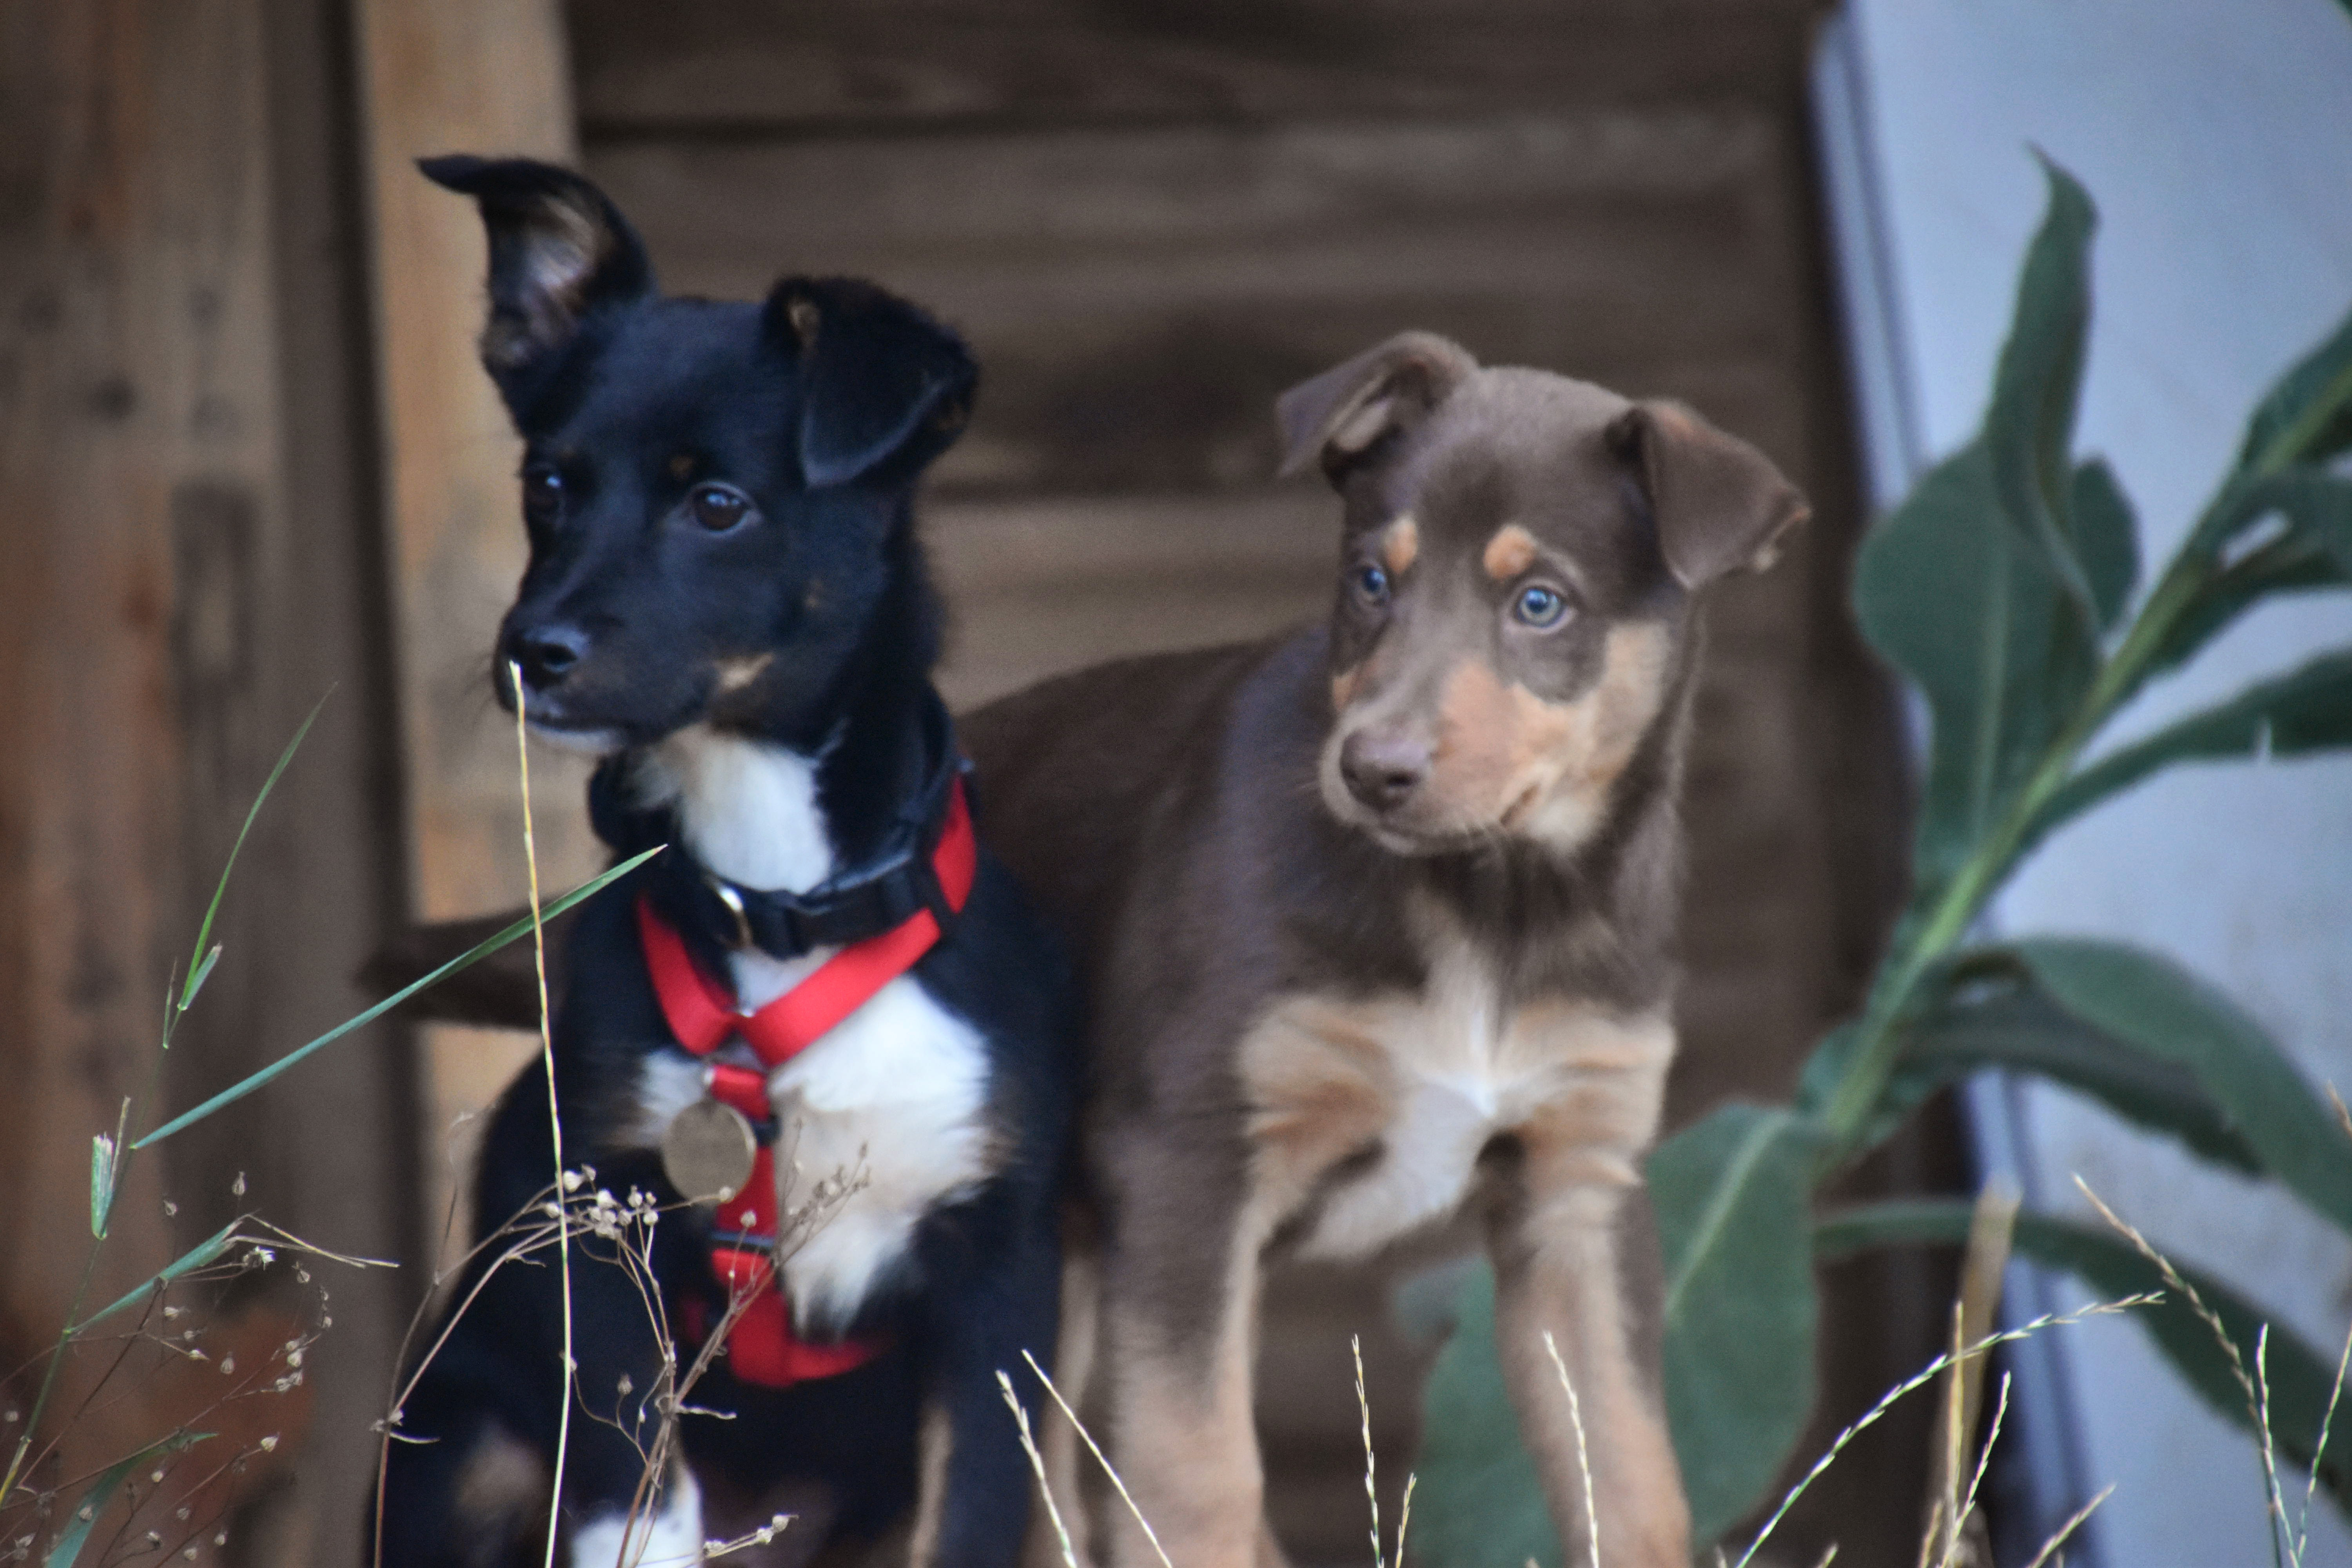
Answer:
[{"xmin": 567, "ymin": 0, "xmax": 1813, "ymax": 136}]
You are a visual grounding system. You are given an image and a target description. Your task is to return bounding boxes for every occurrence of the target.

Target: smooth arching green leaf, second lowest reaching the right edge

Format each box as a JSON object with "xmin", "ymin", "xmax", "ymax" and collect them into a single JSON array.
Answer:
[{"xmin": 2009, "ymin": 938, "xmax": 2352, "ymax": 1232}]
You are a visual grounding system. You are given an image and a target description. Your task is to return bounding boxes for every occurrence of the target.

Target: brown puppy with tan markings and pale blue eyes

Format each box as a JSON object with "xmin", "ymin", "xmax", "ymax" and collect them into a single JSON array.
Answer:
[{"xmin": 964, "ymin": 334, "xmax": 1806, "ymax": 1568}]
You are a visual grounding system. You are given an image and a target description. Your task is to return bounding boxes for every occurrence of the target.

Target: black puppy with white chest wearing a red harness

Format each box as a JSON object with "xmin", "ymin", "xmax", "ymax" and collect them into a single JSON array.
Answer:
[{"xmin": 381, "ymin": 158, "xmax": 1075, "ymax": 1568}]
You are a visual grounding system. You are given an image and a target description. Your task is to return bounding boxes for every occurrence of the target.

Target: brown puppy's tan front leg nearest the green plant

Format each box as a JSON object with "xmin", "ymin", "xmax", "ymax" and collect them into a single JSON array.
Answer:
[{"xmin": 1489, "ymin": 1091, "xmax": 1691, "ymax": 1568}]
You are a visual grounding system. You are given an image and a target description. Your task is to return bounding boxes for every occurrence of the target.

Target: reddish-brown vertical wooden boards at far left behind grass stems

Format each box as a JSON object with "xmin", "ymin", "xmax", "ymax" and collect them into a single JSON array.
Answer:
[{"xmin": 0, "ymin": 0, "xmax": 416, "ymax": 1563}]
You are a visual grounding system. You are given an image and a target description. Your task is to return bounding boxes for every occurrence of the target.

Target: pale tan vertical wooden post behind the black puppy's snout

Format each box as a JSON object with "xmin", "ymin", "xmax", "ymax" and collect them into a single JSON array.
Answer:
[{"xmin": 358, "ymin": 0, "xmax": 597, "ymax": 1232}]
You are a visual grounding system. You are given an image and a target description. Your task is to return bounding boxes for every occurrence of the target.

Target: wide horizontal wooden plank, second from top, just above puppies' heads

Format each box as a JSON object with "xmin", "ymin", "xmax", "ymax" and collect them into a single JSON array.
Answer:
[{"xmin": 590, "ymin": 115, "xmax": 1802, "ymax": 494}]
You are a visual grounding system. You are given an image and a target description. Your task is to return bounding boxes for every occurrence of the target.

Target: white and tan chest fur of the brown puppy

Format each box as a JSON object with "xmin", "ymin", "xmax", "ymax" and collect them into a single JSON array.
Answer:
[{"xmin": 1242, "ymin": 952, "xmax": 1675, "ymax": 1258}]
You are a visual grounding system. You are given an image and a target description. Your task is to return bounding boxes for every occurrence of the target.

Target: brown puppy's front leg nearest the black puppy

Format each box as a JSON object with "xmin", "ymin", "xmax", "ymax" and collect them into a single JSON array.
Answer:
[{"xmin": 1103, "ymin": 1131, "xmax": 1265, "ymax": 1568}]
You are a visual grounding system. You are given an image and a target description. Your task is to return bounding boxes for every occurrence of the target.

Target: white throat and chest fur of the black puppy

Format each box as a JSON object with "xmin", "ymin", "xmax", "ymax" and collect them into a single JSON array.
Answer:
[{"xmin": 637, "ymin": 729, "xmax": 990, "ymax": 1328}]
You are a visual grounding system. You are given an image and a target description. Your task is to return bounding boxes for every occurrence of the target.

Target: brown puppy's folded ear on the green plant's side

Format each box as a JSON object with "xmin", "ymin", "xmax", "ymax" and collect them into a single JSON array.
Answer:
[{"xmin": 1602, "ymin": 399, "xmax": 1813, "ymax": 588}]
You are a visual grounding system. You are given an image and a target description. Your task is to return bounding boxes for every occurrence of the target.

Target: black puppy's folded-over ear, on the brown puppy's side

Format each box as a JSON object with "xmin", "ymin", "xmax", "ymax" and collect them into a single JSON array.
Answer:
[{"xmin": 764, "ymin": 278, "xmax": 981, "ymax": 489}]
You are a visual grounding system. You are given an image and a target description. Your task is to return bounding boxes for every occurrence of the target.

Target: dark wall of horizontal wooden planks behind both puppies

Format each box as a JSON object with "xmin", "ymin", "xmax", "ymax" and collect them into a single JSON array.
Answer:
[{"xmin": 567, "ymin": 0, "xmax": 1940, "ymax": 1561}]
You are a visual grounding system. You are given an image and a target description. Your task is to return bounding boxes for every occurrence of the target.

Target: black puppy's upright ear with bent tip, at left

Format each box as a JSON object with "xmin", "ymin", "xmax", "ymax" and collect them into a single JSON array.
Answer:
[{"xmin": 416, "ymin": 153, "xmax": 654, "ymax": 407}]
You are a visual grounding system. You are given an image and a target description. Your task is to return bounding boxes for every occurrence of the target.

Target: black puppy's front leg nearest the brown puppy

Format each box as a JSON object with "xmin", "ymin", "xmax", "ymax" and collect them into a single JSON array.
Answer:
[{"xmin": 910, "ymin": 1203, "xmax": 1061, "ymax": 1568}]
